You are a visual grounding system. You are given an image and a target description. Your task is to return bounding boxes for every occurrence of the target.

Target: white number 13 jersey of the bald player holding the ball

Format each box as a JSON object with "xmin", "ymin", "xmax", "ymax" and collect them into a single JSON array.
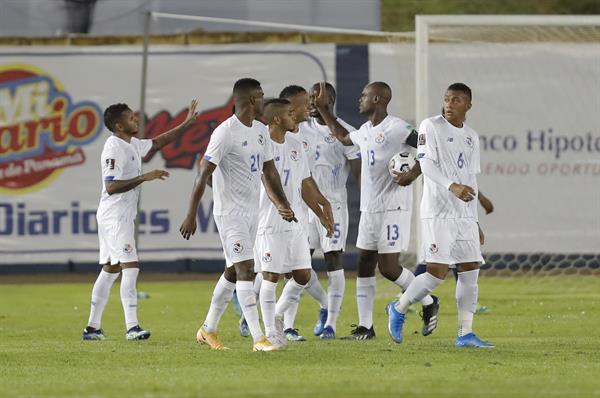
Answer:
[{"xmin": 350, "ymin": 115, "xmax": 412, "ymax": 213}]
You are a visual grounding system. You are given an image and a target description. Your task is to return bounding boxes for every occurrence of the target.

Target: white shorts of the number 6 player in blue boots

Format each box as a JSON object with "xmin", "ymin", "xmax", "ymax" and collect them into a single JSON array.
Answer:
[{"xmin": 421, "ymin": 218, "xmax": 483, "ymax": 265}]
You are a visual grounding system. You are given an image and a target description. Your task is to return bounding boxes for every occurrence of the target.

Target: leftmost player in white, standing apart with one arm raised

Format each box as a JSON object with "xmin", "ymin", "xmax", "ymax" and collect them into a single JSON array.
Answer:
[{"xmin": 83, "ymin": 100, "xmax": 198, "ymax": 340}]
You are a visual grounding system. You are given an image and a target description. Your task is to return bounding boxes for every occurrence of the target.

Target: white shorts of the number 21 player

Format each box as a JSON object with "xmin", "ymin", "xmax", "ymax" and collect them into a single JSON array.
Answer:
[{"xmin": 214, "ymin": 215, "xmax": 258, "ymax": 267}]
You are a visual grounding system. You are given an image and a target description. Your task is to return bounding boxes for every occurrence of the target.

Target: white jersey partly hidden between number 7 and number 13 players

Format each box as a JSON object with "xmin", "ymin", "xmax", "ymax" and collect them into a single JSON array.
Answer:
[{"xmin": 305, "ymin": 118, "xmax": 360, "ymax": 203}]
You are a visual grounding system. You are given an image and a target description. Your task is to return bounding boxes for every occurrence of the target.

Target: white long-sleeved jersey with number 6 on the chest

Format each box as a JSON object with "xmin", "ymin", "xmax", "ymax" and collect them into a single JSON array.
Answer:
[{"xmin": 417, "ymin": 115, "xmax": 481, "ymax": 219}]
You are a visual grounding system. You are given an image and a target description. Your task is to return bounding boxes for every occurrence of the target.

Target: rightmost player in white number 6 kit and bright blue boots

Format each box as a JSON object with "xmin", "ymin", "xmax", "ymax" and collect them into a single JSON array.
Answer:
[{"xmin": 387, "ymin": 83, "xmax": 494, "ymax": 347}]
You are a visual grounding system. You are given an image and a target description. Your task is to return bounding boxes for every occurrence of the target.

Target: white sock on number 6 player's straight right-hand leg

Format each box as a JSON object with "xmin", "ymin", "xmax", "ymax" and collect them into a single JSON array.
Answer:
[{"xmin": 456, "ymin": 269, "xmax": 479, "ymax": 337}]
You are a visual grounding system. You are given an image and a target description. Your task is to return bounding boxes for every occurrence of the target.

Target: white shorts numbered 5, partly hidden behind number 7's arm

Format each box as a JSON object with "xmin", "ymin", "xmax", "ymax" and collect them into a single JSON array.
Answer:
[{"xmin": 308, "ymin": 202, "xmax": 348, "ymax": 253}]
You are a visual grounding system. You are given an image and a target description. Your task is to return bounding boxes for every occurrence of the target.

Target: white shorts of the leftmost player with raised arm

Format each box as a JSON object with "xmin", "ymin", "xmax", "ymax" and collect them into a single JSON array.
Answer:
[{"xmin": 98, "ymin": 220, "xmax": 138, "ymax": 265}]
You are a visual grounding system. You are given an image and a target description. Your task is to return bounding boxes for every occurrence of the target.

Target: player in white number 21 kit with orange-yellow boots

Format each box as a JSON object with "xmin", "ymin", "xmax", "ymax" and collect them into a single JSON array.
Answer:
[{"xmin": 179, "ymin": 78, "xmax": 296, "ymax": 351}]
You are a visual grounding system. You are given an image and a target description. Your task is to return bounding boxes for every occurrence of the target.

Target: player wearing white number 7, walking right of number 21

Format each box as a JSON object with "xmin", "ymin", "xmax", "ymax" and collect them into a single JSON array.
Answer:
[{"xmin": 254, "ymin": 99, "xmax": 333, "ymax": 347}]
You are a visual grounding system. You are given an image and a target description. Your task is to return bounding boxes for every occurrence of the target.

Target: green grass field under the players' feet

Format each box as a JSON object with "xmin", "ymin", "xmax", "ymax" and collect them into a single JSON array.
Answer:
[{"xmin": 0, "ymin": 274, "xmax": 600, "ymax": 398}]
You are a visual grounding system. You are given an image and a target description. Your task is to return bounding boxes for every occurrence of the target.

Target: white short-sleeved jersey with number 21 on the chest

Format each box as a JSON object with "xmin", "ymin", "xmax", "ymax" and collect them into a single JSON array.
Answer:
[{"xmin": 204, "ymin": 115, "xmax": 273, "ymax": 216}]
